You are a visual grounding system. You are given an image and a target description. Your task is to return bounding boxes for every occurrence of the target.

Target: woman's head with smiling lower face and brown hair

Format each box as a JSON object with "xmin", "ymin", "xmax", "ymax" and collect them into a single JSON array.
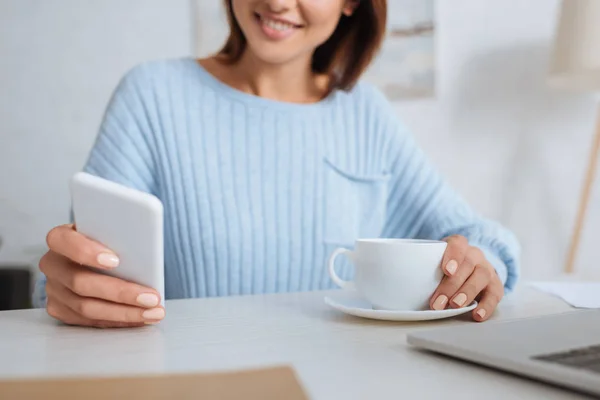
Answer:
[{"xmin": 219, "ymin": 0, "xmax": 387, "ymax": 95}]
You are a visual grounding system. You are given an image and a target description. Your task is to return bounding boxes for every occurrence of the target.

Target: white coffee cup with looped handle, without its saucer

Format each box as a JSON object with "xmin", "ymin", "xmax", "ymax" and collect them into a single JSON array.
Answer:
[{"xmin": 328, "ymin": 239, "xmax": 447, "ymax": 311}]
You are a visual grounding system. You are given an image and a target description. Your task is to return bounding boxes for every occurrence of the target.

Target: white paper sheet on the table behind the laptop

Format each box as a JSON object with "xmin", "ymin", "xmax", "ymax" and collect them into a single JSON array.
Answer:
[{"xmin": 531, "ymin": 282, "xmax": 600, "ymax": 308}]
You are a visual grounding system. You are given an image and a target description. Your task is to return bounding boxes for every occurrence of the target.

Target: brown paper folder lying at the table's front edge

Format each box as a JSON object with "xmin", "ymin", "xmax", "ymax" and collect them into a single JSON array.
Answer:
[{"xmin": 0, "ymin": 366, "xmax": 308, "ymax": 400}]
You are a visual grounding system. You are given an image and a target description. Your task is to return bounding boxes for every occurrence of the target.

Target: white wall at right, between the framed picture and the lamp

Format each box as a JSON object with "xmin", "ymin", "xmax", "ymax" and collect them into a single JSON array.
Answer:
[{"xmin": 398, "ymin": 0, "xmax": 600, "ymax": 278}]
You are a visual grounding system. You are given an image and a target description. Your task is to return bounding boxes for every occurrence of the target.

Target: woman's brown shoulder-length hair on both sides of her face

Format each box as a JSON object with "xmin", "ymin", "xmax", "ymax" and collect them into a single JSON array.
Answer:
[{"xmin": 218, "ymin": 0, "xmax": 387, "ymax": 94}]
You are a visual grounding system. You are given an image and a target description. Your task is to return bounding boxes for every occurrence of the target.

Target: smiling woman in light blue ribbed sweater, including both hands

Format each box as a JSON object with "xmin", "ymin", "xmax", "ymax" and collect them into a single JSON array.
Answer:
[{"xmin": 37, "ymin": 0, "xmax": 518, "ymax": 327}]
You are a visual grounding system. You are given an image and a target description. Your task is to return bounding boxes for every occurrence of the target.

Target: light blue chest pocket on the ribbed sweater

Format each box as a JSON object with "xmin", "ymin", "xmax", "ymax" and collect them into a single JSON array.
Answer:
[{"xmin": 323, "ymin": 159, "xmax": 389, "ymax": 246}]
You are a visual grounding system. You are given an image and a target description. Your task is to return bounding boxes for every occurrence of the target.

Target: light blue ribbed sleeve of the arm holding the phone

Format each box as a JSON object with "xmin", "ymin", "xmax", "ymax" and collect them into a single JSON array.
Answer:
[{"xmin": 32, "ymin": 66, "xmax": 156, "ymax": 307}]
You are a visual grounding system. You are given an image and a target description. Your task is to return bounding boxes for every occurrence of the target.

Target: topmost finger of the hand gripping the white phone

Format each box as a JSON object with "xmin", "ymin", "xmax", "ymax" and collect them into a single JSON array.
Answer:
[{"xmin": 46, "ymin": 225, "xmax": 119, "ymax": 269}]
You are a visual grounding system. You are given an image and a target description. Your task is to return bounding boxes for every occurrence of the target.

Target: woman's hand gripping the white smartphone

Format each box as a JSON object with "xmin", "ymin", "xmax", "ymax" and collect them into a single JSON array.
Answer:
[{"xmin": 40, "ymin": 225, "xmax": 165, "ymax": 328}]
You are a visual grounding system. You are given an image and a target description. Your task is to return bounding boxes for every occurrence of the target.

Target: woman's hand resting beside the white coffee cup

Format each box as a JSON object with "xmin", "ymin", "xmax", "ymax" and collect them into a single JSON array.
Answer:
[{"xmin": 430, "ymin": 235, "xmax": 504, "ymax": 321}]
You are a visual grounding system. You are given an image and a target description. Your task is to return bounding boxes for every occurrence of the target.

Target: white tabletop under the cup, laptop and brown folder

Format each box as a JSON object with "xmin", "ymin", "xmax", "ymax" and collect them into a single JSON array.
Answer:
[{"xmin": 0, "ymin": 287, "xmax": 592, "ymax": 400}]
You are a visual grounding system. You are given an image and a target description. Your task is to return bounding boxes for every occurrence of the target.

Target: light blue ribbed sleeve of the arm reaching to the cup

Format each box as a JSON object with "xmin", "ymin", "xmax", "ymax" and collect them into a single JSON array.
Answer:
[{"xmin": 384, "ymin": 111, "xmax": 520, "ymax": 292}]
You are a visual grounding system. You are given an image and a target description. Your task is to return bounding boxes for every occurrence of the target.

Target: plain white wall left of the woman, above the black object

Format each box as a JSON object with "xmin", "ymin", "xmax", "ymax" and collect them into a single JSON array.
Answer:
[{"xmin": 0, "ymin": 0, "xmax": 193, "ymax": 268}]
